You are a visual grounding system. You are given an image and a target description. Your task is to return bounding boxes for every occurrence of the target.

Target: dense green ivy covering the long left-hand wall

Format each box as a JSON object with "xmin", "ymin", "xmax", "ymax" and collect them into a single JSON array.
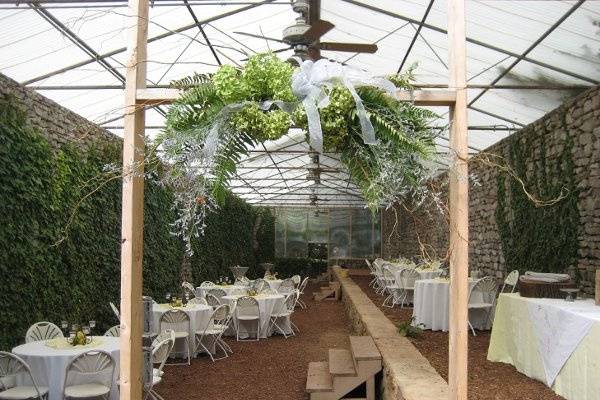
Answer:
[{"xmin": 0, "ymin": 79, "xmax": 274, "ymax": 350}]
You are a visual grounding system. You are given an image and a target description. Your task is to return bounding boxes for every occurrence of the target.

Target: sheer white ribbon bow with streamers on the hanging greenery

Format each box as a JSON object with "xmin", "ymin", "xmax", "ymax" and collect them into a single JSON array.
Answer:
[{"xmin": 292, "ymin": 59, "xmax": 396, "ymax": 153}]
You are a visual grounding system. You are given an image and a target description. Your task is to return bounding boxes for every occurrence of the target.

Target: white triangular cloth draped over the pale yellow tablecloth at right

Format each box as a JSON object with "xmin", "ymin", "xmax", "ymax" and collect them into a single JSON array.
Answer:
[{"xmin": 527, "ymin": 299, "xmax": 594, "ymax": 387}]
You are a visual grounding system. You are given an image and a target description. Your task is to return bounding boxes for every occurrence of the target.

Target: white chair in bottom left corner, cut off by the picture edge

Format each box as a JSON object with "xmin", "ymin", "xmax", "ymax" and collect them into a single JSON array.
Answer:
[{"xmin": 0, "ymin": 351, "xmax": 48, "ymax": 400}]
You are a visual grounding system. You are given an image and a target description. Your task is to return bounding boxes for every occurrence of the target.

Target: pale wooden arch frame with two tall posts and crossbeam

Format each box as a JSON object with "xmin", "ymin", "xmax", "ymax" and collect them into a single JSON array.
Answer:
[{"xmin": 120, "ymin": 0, "xmax": 469, "ymax": 400}]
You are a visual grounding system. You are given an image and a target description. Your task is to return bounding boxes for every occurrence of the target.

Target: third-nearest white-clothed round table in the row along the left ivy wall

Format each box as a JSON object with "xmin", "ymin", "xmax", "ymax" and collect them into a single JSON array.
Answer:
[{"xmin": 223, "ymin": 294, "xmax": 292, "ymax": 339}]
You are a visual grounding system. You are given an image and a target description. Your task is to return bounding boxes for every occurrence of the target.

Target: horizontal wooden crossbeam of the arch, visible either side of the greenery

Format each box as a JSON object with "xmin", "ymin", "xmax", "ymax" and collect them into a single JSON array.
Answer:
[{"xmin": 136, "ymin": 88, "xmax": 456, "ymax": 106}]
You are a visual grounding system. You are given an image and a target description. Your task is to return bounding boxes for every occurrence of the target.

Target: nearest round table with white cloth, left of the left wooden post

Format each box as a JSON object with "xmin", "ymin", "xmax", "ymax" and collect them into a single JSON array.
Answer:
[{"xmin": 12, "ymin": 336, "xmax": 119, "ymax": 400}]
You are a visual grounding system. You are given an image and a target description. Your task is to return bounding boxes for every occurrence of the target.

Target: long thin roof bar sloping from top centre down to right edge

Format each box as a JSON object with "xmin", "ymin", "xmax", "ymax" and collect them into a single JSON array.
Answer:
[{"xmin": 340, "ymin": 0, "xmax": 600, "ymax": 85}]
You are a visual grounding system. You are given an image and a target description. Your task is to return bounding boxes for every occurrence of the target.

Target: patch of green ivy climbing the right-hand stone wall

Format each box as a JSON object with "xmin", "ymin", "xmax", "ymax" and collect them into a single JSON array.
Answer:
[{"xmin": 495, "ymin": 112, "xmax": 579, "ymax": 273}]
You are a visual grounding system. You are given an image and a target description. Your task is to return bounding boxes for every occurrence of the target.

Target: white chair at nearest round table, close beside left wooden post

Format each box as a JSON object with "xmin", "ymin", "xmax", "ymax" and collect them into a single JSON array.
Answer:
[{"xmin": 63, "ymin": 350, "xmax": 115, "ymax": 398}]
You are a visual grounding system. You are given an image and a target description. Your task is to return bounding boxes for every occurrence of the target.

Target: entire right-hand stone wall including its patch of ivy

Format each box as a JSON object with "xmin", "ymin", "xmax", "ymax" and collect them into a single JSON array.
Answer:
[{"xmin": 383, "ymin": 87, "xmax": 600, "ymax": 294}]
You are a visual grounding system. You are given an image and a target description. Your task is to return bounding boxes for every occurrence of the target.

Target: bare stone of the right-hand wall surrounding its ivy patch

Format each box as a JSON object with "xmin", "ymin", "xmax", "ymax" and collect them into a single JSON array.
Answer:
[{"xmin": 383, "ymin": 87, "xmax": 600, "ymax": 294}]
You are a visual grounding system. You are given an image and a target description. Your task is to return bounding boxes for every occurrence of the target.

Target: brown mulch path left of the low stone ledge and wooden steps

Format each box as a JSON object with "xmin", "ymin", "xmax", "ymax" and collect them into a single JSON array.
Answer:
[{"xmin": 156, "ymin": 284, "xmax": 350, "ymax": 400}]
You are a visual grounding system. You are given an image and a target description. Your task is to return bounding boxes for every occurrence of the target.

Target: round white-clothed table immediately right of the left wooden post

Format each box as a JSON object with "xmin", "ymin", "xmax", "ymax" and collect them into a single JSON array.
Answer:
[{"xmin": 152, "ymin": 304, "xmax": 214, "ymax": 357}]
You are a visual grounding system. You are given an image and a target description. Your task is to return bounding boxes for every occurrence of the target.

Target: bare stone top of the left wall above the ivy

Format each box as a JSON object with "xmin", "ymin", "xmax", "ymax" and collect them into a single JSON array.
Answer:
[{"xmin": 0, "ymin": 74, "xmax": 120, "ymax": 148}]
